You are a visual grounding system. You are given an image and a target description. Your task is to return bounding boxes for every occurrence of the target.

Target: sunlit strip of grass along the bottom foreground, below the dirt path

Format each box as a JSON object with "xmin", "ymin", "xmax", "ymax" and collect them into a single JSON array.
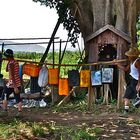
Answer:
[{"xmin": 0, "ymin": 119, "xmax": 103, "ymax": 140}]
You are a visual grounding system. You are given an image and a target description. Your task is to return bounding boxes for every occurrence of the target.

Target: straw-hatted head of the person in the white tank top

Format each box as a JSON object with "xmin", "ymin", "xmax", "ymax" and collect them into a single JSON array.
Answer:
[{"xmin": 125, "ymin": 47, "xmax": 140, "ymax": 60}]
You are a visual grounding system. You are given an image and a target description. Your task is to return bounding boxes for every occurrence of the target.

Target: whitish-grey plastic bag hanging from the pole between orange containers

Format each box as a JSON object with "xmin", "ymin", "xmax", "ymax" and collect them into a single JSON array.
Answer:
[{"xmin": 38, "ymin": 65, "xmax": 48, "ymax": 87}]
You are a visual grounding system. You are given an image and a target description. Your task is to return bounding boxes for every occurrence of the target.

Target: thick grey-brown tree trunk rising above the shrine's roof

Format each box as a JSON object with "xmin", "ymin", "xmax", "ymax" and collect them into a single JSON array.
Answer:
[{"xmin": 71, "ymin": 0, "xmax": 140, "ymax": 44}]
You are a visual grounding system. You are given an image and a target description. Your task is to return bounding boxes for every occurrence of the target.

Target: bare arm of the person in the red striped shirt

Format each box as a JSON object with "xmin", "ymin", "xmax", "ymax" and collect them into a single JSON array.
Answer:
[{"xmin": 9, "ymin": 63, "xmax": 19, "ymax": 93}]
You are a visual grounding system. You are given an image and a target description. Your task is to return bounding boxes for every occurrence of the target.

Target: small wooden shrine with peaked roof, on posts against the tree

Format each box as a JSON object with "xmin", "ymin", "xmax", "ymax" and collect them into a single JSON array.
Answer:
[{"xmin": 86, "ymin": 25, "xmax": 131, "ymax": 108}]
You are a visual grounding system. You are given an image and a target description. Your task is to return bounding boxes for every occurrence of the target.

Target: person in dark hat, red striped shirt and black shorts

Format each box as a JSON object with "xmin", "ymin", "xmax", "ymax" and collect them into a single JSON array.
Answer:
[{"xmin": 2, "ymin": 49, "xmax": 22, "ymax": 115}]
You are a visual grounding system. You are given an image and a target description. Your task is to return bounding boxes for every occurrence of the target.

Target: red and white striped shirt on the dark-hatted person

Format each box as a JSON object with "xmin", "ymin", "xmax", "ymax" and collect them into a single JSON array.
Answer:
[{"xmin": 6, "ymin": 59, "xmax": 21, "ymax": 88}]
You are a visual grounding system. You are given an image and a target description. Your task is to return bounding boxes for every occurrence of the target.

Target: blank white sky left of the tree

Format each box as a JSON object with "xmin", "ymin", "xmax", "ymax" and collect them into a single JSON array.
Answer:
[{"xmin": 0, "ymin": 0, "xmax": 74, "ymax": 48}]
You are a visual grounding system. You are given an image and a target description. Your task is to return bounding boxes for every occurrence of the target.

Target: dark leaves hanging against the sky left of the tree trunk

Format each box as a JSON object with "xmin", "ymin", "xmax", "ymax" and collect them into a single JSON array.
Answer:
[{"xmin": 33, "ymin": 0, "xmax": 80, "ymax": 47}]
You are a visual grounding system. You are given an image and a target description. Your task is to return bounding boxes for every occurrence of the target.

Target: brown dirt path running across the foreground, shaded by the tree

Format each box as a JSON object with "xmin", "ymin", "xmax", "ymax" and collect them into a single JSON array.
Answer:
[{"xmin": 0, "ymin": 105, "xmax": 140, "ymax": 140}]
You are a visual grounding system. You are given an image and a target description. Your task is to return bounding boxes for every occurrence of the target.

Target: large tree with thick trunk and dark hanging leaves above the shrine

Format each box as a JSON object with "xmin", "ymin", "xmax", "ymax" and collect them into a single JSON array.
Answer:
[{"xmin": 33, "ymin": 0, "xmax": 140, "ymax": 47}]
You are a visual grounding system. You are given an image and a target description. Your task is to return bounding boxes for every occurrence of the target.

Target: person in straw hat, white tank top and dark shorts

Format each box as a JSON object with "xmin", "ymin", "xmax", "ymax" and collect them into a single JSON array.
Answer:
[{"xmin": 117, "ymin": 47, "xmax": 140, "ymax": 114}]
